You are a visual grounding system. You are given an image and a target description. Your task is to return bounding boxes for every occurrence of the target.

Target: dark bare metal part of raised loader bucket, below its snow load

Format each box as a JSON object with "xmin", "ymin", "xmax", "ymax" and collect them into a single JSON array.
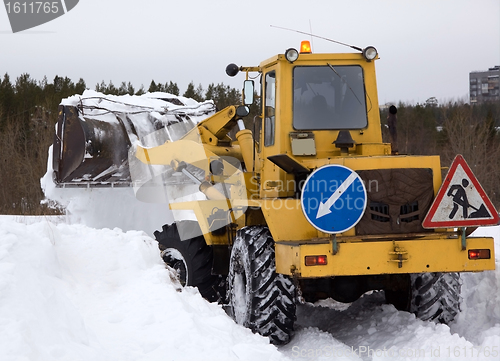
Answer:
[{"xmin": 52, "ymin": 105, "xmax": 131, "ymax": 186}]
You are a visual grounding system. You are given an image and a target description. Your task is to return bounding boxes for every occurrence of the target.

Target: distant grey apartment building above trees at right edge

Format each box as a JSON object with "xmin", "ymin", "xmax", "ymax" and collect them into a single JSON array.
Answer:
[{"xmin": 469, "ymin": 65, "xmax": 500, "ymax": 104}]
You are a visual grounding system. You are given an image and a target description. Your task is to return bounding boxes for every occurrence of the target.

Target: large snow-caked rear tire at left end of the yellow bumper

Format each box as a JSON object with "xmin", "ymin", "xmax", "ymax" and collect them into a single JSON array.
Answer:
[{"xmin": 228, "ymin": 226, "xmax": 296, "ymax": 345}]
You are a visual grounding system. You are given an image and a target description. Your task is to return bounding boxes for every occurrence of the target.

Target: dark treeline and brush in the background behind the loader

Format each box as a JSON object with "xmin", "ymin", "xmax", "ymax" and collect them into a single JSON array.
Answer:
[{"xmin": 0, "ymin": 74, "xmax": 500, "ymax": 215}]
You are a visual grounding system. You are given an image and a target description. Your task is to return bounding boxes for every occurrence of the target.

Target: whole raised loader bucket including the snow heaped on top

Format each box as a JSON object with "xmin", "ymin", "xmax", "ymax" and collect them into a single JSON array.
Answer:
[{"xmin": 48, "ymin": 90, "xmax": 215, "ymax": 188}]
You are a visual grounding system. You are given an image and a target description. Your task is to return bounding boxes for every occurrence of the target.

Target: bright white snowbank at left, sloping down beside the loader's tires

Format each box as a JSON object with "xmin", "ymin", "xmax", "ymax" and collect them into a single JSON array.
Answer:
[{"xmin": 0, "ymin": 217, "xmax": 284, "ymax": 361}]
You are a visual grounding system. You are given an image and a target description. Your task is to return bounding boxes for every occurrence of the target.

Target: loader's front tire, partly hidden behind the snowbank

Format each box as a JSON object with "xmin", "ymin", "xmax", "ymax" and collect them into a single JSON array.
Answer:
[{"xmin": 154, "ymin": 221, "xmax": 223, "ymax": 302}]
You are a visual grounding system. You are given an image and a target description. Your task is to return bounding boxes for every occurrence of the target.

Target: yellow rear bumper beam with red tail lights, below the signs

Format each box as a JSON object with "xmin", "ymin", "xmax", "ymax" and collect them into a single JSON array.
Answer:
[{"xmin": 276, "ymin": 233, "xmax": 495, "ymax": 278}]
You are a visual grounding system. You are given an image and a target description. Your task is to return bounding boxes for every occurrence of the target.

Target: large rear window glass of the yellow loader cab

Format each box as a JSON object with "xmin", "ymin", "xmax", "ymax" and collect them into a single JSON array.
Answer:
[{"xmin": 293, "ymin": 65, "xmax": 368, "ymax": 130}]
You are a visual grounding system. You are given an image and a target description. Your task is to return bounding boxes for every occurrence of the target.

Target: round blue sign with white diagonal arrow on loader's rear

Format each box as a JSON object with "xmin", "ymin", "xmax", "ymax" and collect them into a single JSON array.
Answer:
[{"xmin": 300, "ymin": 164, "xmax": 367, "ymax": 233}]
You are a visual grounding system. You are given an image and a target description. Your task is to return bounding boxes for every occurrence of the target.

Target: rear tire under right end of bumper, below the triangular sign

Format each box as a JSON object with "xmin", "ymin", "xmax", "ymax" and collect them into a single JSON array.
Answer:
[{"xmin": 385, "ymin": 273, "xmax": 461, "ymax": 324}]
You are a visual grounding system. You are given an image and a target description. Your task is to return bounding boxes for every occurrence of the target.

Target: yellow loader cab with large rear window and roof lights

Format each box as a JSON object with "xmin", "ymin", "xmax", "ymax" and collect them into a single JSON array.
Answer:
[{"xmin": 254, "ymin": 44, "xmax": 390, "ymax": 198}]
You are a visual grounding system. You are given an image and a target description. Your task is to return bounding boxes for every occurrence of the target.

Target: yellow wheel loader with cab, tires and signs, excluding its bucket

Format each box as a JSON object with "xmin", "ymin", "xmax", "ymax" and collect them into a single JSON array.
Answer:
[{"xmin": 49, "ymin": 41, "xmax": 498, "ymax": 344}]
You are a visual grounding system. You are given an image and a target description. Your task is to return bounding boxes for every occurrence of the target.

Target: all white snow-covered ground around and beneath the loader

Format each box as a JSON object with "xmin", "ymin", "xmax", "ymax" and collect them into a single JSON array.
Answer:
[{"xmin": 0, "ymin": 216, "xmax": 500, "ymax": 361}]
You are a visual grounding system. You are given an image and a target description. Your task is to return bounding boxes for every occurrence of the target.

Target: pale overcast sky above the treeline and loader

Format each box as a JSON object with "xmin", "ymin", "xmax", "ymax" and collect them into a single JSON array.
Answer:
[{"xmin": 0, "ymin": 0, "xmax": 500, "ymax": 104}]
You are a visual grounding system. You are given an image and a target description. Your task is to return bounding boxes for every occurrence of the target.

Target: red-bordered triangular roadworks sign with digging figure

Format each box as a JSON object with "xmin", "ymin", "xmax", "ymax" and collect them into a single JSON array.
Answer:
[{"xmin": 422, "ymin": 154, "xmax": 500, "ymax": 228}]
